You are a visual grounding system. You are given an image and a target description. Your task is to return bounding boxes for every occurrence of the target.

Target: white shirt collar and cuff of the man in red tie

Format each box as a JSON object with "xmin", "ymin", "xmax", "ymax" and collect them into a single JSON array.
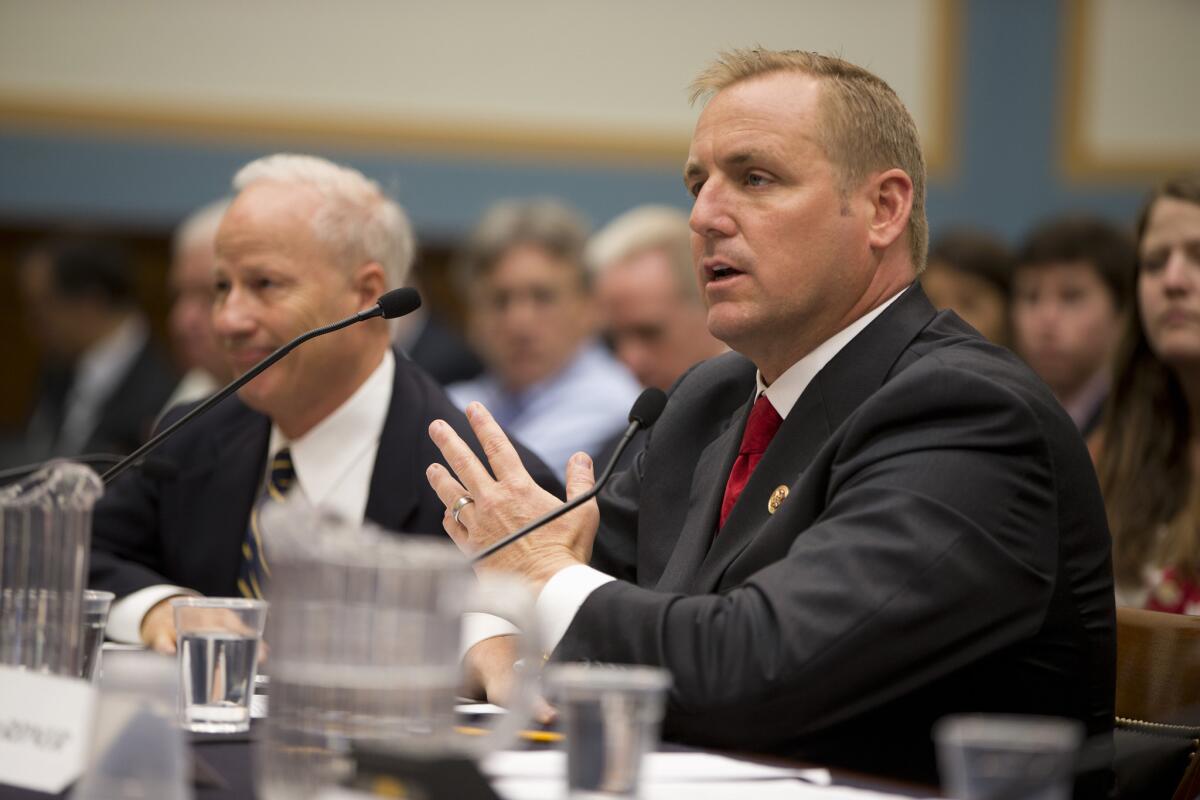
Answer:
[{"xmin": 536, "ymin": 291, "xmax": 904, "ymax": 652}]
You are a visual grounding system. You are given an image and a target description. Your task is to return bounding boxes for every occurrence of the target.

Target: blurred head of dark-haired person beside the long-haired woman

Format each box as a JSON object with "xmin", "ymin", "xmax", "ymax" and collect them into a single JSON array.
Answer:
[{"xmin": 1013, "ymin": 217, "xmax": 1136, "ymax": 437}]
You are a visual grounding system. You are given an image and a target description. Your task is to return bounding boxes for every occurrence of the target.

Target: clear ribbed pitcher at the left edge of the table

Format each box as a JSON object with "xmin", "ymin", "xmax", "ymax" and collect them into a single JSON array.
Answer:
[{"xmin": 0, "ymin": 462, "xmax": 103, "ymax": 676}]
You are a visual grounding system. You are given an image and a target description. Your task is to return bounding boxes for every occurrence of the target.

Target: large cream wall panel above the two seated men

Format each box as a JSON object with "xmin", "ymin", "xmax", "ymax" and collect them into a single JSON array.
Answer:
[{"xmin": 0, "ymin": 0, "xmax": 956, "ymax": 163}]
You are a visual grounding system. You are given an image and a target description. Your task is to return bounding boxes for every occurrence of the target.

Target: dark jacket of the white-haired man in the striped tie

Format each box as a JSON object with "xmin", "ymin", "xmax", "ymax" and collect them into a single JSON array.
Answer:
[{"xmin": 89, "ymin": 354, "xmax": 563, "ymax": 597}]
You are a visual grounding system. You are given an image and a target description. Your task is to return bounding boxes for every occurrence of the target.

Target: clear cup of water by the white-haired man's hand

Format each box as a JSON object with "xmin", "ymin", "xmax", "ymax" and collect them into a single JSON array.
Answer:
[{"xmin": 170, "ymin": 597, "xmax": 268, "ymax": 733}]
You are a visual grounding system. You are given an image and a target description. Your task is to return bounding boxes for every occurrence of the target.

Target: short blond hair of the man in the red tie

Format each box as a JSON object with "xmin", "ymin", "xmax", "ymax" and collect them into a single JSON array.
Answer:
[{"xmin": 691, "ymin": 48, "xmax": 929, "ymax": 272}]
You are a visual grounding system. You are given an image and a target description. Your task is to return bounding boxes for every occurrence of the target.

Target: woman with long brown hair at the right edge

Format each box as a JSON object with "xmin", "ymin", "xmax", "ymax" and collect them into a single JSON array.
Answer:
[{"xmin": 1094, "ymin": 176, "xmax": 1200, "ymax": 614}]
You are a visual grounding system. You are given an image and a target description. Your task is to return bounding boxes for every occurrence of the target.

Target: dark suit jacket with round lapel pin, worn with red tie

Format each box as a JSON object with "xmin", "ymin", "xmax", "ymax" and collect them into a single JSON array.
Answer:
[{"xmin": 554, "ymin": 287, "xmax": 1115, "ymax": 796}]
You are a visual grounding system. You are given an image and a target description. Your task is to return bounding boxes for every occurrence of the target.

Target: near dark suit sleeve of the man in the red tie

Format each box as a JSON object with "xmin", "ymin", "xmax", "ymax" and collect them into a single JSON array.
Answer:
[{"xmin": 556, "ymin": 359, "xmax": 1057, "ymax": 747}]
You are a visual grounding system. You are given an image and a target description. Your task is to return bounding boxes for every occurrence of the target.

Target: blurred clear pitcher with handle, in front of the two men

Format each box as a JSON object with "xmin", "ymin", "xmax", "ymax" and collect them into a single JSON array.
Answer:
[{"xmin": 256, "ymin": 503, "xmax": 539, "ymax": 800}]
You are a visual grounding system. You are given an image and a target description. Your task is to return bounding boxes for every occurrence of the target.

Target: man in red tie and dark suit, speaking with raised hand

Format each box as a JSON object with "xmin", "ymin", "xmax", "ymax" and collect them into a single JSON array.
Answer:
[{"xmin": 428, "ymin": 50, "xmax": 1115, "ymax": 796}]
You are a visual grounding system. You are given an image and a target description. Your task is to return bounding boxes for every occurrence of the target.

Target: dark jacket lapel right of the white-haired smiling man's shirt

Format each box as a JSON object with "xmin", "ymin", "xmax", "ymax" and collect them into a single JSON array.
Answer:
[{"xmin": 366, "ymin": 354, "xmax": 426, "ymax": 531}]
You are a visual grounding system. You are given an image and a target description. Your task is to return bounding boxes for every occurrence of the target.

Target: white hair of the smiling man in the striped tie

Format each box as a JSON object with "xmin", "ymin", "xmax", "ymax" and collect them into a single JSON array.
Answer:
[{"xmin": 233, "ymin": 154, "xmax": 416, "ymax": 289}]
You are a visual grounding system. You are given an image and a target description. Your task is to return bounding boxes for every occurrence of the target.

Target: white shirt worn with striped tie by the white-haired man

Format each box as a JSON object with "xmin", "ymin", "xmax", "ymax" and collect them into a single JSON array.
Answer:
[{"xmin": 106, "ymin": 349, "xmax": 391, "ymax": 644}]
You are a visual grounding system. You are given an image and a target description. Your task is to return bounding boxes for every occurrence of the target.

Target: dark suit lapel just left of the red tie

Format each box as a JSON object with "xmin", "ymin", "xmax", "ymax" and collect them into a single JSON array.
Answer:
[{"xmin": 657, "ymin": 392, "xmax": 754, "ymax": 591}]
